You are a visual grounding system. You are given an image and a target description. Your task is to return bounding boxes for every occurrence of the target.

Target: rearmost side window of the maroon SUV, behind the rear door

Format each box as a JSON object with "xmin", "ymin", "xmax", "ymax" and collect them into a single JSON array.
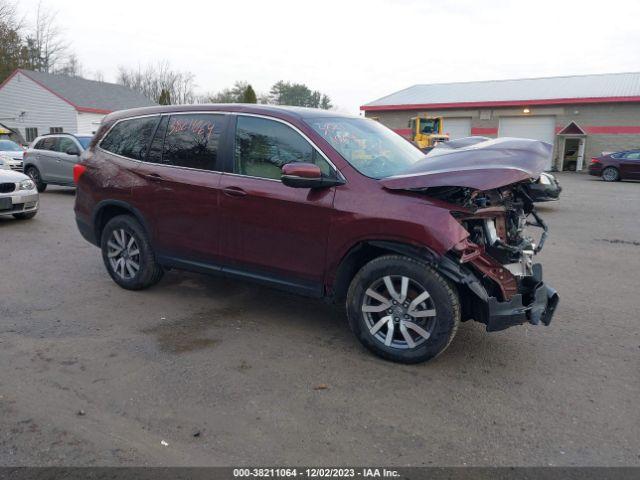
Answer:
[{"xmin": 100, "ymin": 116, "xmax": 160, "ymax": 160}]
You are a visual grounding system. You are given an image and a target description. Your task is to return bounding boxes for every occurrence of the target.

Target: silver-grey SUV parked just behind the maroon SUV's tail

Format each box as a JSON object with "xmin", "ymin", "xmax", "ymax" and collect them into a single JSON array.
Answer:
[{"xmin": 24, "ymin": 133, "xmax": 91, "ymax": 192}]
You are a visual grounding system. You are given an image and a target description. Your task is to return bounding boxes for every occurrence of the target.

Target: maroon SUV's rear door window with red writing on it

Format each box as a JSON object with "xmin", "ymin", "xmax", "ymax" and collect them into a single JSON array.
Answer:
[{"xmin": 150, "ymin": 114, "xmax": 225, "ymax": 170}]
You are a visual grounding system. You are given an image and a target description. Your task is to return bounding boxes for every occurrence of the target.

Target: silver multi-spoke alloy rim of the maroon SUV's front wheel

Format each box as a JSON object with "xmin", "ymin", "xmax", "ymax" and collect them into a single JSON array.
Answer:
[{"xmin": 361, "ymin": 275, "xmax": 436, "ymax": 349}]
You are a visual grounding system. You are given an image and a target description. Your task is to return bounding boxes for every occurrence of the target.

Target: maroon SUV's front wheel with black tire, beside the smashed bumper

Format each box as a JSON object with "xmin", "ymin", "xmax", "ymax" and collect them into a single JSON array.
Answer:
[{"xmin": 346, "ymin": 255, "xmax": 460, "ymax": 363}]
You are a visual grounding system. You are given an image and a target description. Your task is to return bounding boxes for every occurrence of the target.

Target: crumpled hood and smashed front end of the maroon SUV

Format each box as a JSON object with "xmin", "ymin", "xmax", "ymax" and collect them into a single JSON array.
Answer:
[{"xmin": 385, "ymin": 139, "xmax": 559, "ymax": 331}]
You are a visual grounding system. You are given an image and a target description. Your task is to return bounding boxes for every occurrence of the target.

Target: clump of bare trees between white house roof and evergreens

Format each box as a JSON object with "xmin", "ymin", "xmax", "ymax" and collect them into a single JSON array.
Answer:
[{"xmin": 117, "ymin": 61, "xmax": 196, "ymax": 104}]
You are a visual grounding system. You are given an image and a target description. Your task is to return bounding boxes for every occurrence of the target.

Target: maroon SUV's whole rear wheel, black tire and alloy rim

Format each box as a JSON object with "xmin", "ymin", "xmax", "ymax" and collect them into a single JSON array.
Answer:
[{"xmin": 100, "ymin": 215, "xmax": 164, "ymax": 290}]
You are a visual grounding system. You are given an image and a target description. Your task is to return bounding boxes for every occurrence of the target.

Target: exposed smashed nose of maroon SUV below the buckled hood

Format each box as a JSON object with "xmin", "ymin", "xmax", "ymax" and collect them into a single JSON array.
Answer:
[{"xmin": 439, "ymin": 185, "xmax": 559, "ymax": 332}]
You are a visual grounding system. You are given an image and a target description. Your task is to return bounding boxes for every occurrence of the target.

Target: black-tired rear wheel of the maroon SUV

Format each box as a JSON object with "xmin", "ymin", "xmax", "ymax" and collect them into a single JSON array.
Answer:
[{"xmin": 100, "ymin": 215, "xmax": 164, "ymax": 290}]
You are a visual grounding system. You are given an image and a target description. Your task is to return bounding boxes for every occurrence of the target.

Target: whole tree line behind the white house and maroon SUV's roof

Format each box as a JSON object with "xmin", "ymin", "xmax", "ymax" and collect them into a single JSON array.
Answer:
[{"xmin": 0, "ymin": 0, "xmax": 333, "ymax": 110}]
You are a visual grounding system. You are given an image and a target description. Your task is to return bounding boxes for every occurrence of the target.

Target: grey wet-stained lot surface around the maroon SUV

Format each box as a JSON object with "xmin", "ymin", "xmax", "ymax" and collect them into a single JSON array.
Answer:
[{"xmin": 0, "ymin": 174, "xmax": 640, "ymax": 466}]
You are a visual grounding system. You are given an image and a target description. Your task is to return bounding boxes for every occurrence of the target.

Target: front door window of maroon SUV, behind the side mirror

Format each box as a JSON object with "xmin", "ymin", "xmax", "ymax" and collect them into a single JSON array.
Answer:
[{"xmin": 234, "ymin": 116, "xmax": 333, "ymax": 180}]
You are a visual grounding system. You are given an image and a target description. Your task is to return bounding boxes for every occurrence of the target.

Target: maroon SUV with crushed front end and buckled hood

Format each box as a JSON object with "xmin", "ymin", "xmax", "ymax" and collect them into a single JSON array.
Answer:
[{"xmin": 74, "ymin": 105, "xmax": 558, "ymax": 363}]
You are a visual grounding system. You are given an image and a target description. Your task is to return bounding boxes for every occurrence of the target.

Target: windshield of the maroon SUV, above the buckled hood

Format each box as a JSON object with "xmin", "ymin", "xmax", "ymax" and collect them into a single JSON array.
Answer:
[{"xmin": 305, "ymin": 117, "xmax": 424, "ymax": 179}]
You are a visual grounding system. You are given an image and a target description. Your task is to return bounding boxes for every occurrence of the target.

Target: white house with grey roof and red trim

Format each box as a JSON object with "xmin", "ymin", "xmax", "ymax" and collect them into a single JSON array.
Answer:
[{"xmin": 0, "ymin": 69, "xmax": 154, "ymax": 142}]
